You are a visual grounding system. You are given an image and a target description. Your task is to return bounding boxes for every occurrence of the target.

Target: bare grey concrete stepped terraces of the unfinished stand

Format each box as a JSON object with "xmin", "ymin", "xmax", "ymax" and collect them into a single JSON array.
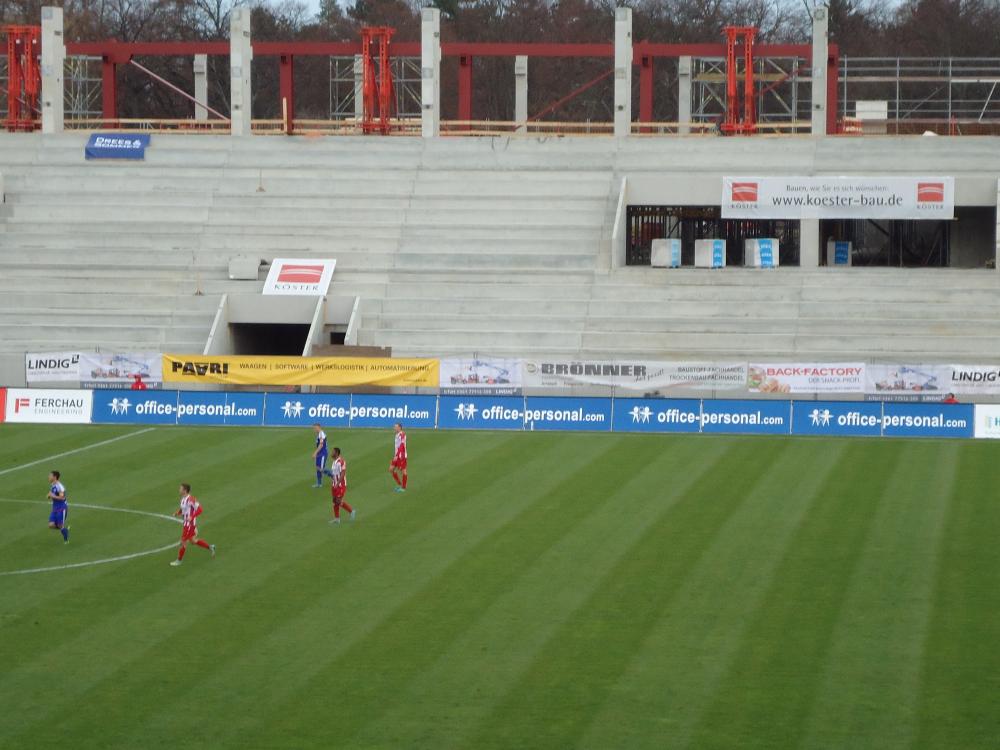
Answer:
[{"xmin": 0, "ymin": 134, "xmax": 1000, "ymax": 382}]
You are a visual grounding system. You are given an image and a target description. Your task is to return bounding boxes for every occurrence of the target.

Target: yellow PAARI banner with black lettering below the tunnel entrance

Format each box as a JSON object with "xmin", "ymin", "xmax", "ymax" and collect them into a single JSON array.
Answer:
[{"xmin": 163, "ymin": 354, "xmax": 440, "ymax": 388}]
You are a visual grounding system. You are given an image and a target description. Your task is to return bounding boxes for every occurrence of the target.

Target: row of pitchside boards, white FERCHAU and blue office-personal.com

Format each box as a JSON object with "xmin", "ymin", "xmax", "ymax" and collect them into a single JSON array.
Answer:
[{"xmin": 0, "ymin": 388, "xmax": 964, "ymax": 438}]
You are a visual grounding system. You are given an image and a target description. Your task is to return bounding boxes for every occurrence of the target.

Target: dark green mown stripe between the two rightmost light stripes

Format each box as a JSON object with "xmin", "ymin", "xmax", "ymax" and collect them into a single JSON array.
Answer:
[{"xmin": 690, "ymin": 441, "xmax": 905, "ymax": 748}]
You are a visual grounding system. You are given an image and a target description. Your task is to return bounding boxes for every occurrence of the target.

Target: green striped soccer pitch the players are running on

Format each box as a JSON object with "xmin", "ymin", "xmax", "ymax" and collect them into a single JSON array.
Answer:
[{"xmin": 0, "ymin": 425, "xmax": 1000, "ymax": 750}]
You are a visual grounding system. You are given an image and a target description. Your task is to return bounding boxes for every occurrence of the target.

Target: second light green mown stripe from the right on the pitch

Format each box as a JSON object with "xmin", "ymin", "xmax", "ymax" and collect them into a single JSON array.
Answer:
[{"xmin": 581, "ymin": 441, "xmax": 851, "ymax": 748}]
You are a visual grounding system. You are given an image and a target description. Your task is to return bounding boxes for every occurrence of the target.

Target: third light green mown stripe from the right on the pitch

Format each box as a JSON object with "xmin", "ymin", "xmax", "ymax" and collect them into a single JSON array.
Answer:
[{"xmin": 350, "ymin": 436, "xmax": 725, "ymax": 747}]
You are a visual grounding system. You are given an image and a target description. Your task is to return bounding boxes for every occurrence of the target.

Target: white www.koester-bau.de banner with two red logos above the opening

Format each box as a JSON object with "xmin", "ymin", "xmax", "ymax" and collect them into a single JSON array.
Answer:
[{"xmin": 722, "ymin": 176, "xmax": 955, "ymax": 219}]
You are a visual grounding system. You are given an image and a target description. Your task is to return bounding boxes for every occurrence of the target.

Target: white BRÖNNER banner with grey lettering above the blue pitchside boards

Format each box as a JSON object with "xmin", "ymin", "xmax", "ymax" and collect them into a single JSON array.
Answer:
[{"xmin": 522, "ymin": 359, "xmax": 747, "ymax": 391}]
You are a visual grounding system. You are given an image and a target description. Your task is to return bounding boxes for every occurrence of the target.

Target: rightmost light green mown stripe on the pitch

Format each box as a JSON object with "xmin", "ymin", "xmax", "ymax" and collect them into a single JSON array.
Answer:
[{"xmin": 806, "ymin": 443, "xmax": 958, "ymax": 750}]
